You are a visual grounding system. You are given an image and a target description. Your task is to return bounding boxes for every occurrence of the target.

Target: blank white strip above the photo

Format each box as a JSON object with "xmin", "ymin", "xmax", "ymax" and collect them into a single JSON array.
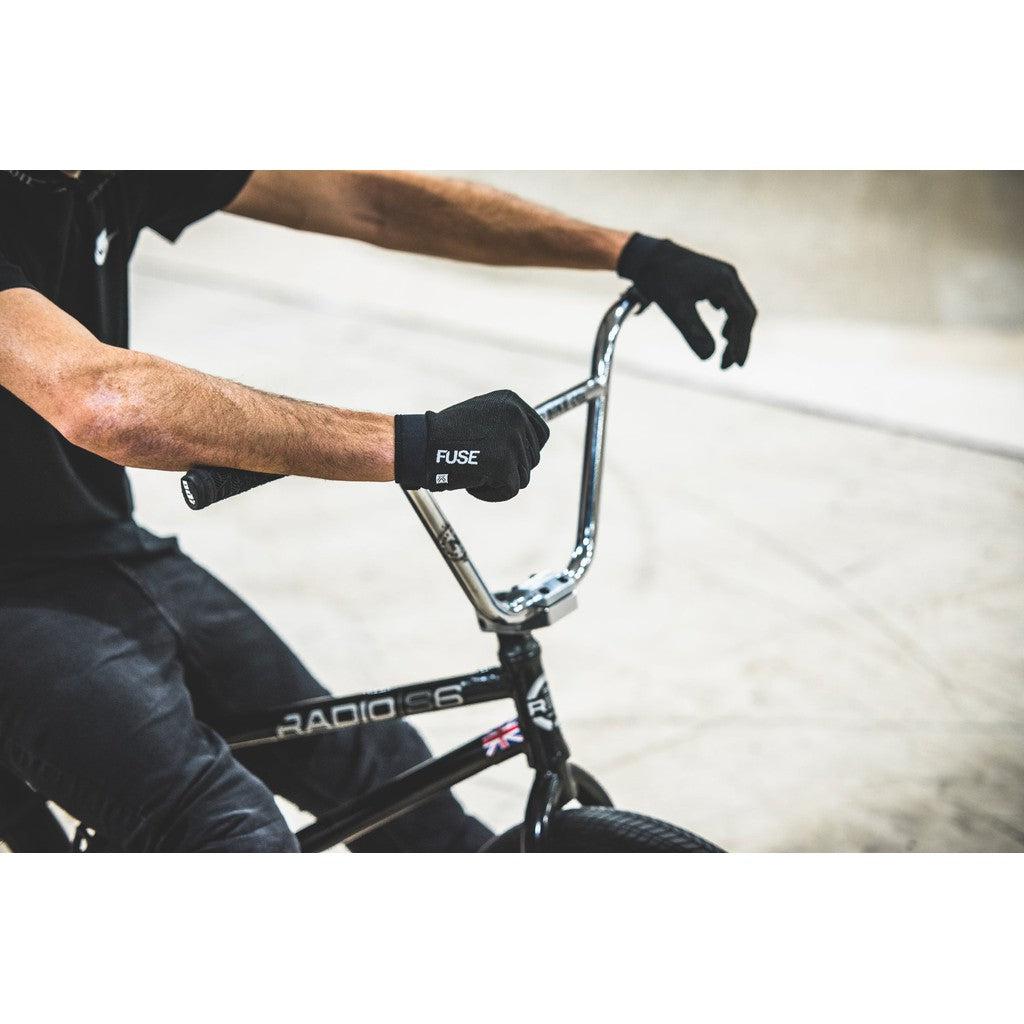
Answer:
[{"xmin": 0, "ymin": 0, "xmax": 1020, "ymax": 169}]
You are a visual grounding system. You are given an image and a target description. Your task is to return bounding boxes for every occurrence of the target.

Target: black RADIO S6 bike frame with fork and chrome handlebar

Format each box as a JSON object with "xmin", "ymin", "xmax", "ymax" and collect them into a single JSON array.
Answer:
[{"xmin": 220, "ymin": 288, "xmax": 646, "ymax": 853}]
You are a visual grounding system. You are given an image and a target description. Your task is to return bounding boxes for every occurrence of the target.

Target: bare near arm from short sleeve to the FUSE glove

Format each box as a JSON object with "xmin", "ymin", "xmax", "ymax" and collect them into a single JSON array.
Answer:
[{"xmin": 0, "ymin": 289, "xmax": 394, "ymax": 480}]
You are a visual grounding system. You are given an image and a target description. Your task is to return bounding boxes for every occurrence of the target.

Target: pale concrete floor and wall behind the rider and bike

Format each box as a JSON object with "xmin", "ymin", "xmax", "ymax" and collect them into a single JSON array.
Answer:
[{"xmin": 123, "ymin": 172, "xmax": 1024, "ymax": 850}]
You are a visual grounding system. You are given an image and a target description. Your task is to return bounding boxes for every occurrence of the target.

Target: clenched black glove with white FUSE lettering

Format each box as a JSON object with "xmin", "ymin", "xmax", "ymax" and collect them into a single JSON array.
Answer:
[{"xmin": 394, "ymin": 391, "xmax": 551, "ymax": 502}]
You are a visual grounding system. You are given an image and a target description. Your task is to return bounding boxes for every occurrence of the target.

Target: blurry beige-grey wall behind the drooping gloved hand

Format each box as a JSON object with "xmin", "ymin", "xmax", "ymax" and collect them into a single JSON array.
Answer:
[{"xmin": 462, "ymin": 171, "xmax": 1024, "ymax": 328}]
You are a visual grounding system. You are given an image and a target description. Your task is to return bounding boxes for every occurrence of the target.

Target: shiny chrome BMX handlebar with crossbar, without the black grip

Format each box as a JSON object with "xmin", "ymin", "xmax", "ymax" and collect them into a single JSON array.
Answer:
[{"xmin": 404, "ymin": 288, "xmax": 646, "ymax": 633}]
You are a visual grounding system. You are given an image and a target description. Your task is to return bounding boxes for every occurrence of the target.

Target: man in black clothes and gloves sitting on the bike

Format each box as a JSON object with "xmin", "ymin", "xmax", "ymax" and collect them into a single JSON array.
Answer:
[{"xmin": 0, "ymin": 171, "xmax": 756, "ymax": 851}]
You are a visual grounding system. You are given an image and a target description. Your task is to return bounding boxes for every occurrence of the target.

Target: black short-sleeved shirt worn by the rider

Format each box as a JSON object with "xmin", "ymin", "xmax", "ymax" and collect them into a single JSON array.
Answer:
[{"xmin": 0, "ymin": 171, "xmax": 249, "ymax": 574}]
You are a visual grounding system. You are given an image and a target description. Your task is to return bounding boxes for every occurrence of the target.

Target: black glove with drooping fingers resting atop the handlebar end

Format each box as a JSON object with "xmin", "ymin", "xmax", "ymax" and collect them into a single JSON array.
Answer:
[{"xmin": 615, "ymin": 234, "xmax": 758, "ymax": 370}]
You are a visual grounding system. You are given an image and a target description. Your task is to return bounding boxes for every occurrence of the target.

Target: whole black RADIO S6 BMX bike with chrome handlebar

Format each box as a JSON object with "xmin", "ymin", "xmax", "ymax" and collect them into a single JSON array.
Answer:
[{"xmin": 0, "ymin": 288, "xmax": 720, "ymax": 853}]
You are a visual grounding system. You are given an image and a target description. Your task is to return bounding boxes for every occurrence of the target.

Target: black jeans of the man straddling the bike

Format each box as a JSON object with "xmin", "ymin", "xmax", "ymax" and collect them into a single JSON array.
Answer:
[{"xmin": 0, "ymin": 551, "xmax": 490, "ymax": 851}]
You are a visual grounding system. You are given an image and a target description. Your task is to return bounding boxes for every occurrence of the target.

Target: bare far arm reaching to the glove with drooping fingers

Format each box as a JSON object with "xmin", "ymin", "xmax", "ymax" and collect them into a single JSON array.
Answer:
[{"xmin": 228, "ymin": 171, "xmax": 629, "ymax": 270}]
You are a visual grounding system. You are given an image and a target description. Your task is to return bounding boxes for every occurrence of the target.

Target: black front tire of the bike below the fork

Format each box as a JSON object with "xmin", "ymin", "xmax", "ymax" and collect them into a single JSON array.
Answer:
[{"xmin": 483, "ymin": 807, "xmax": 725, "ymax": 853}]
